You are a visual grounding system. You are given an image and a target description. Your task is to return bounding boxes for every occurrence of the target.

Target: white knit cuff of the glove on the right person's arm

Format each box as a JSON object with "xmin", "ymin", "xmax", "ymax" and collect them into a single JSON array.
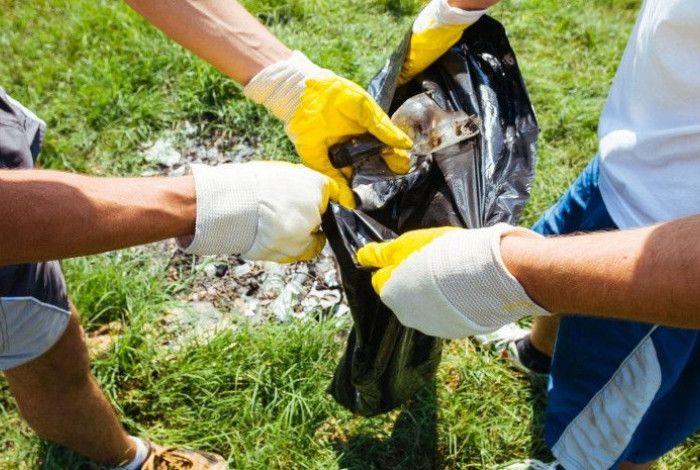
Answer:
[{"xmin": 431, "ymin": 223, "xmax": 549, "ymax": 334}]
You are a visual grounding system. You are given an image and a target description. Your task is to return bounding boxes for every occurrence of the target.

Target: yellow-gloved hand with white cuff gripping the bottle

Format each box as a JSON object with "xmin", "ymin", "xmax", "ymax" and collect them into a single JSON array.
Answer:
[{"xmin": 244, "ymin": 51, "xmax": 412, "ymax": 207}]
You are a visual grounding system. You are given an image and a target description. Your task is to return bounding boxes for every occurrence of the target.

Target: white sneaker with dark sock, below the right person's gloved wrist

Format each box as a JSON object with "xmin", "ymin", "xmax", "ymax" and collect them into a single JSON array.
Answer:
[{"xmin": 474, "ymin": 324, "xmax": 552, "ymax": 376}]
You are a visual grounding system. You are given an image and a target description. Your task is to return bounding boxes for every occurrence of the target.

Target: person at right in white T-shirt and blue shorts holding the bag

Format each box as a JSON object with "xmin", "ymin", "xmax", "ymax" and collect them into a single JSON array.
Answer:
[{"xmin": 358, "ymin": 0, "xmax": 700, "ymax": 469}]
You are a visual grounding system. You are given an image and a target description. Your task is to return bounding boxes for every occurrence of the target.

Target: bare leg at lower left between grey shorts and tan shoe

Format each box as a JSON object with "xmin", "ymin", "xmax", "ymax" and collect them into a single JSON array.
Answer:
[{"xmin": 5, "ymin": 307, "xmax": 136, "ymax": 465}]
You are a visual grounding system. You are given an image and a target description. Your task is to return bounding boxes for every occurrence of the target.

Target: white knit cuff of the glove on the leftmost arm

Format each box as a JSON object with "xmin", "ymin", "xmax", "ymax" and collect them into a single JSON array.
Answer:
[{"xmin": 178, "ymin": 164, "xmax": 258, "ymax": 255}]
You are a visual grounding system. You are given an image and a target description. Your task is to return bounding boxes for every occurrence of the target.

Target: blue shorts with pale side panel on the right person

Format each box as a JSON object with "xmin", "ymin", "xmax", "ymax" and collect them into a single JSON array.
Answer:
[{"xmin": 533, "ymin": 158, "xmax": 700, "ymax": 470}]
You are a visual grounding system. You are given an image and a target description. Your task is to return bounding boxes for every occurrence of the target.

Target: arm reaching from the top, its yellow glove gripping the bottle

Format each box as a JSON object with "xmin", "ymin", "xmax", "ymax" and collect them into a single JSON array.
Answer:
[{"xmin": 127, "ymin": 0, "xmax": 412, "ymax": 206}]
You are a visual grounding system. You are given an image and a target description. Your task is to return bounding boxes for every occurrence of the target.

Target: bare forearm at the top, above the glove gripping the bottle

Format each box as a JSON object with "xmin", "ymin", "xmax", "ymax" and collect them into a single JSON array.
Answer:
[{"xmin": 126, "ymin": 0, "xmax": 291, "ymax": 84}]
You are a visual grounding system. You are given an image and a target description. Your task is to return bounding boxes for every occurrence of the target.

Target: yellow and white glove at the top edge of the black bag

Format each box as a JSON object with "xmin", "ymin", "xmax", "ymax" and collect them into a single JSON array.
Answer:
[{"xmin": 399, "ymin": 0, "xmax": 486, "ymax": 85}]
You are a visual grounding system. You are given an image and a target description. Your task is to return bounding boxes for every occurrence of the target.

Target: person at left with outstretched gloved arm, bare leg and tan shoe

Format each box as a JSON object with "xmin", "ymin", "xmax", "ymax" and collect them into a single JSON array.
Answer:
[{"xmin": 0, "ymin": 89, "xmax": 339, "ymax": 469}]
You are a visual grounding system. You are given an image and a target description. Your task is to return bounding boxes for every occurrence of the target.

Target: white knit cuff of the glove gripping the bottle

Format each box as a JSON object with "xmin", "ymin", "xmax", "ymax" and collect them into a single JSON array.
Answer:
[{"xmin": 243, "ymin": 51, "xmax": 333, "ymax": 124}]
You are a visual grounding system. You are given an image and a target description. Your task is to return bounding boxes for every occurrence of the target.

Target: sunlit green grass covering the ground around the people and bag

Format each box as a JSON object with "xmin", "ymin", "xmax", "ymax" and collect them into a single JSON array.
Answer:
[{"xmin": 0, "ymin": 0, "xmax": 700, "ymax": 469}]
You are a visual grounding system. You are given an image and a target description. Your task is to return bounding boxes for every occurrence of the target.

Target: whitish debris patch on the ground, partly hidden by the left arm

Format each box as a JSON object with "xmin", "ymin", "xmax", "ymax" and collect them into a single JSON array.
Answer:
[{"xmin": 138, "ymin": 123, "xmax": 349, "ymax": 349}]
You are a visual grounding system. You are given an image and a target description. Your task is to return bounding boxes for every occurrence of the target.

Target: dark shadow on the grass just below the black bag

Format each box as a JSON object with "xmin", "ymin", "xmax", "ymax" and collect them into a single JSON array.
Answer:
[{"xmin": 334, "ymin": 382, "xmax": 440, "ymax": 470}]
